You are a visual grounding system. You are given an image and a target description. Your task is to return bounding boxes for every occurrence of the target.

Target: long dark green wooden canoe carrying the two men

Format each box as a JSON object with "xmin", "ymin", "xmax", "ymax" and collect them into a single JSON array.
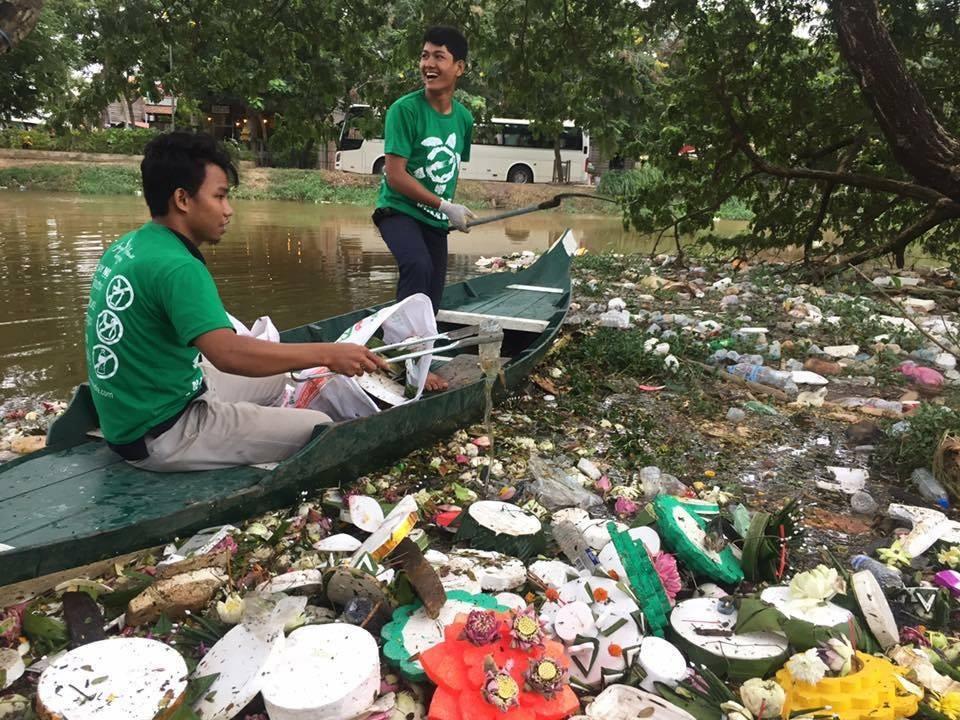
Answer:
[{"xmin": 0, "ymin": 231, "xmax": 577, "ymax": 586}]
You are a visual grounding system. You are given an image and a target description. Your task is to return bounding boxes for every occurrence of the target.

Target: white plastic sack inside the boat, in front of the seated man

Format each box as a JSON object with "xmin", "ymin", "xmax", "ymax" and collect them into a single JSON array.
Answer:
[{"xmin": 293, "ymin": 294, "xmax": 437, "ymax": 420}]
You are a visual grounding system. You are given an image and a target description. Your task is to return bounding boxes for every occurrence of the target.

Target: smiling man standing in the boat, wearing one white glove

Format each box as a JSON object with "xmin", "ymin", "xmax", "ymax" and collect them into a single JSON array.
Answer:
[{"xmin": 373, "ymin": 26, "xmax": 475, "ymax": 390}]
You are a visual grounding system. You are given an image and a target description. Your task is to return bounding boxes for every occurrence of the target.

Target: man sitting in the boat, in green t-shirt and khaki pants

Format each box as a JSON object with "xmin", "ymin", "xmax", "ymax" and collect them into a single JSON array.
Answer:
[{"xmin": 86, "ymin": 132, "xmax": 387, "ymax": 472}]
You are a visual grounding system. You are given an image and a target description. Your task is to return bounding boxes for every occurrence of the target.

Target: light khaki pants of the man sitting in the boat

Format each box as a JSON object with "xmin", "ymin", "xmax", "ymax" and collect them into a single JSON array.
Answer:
[{"xmin": 130, "ymin": 363, "xmax": 332, "ymax": 472}]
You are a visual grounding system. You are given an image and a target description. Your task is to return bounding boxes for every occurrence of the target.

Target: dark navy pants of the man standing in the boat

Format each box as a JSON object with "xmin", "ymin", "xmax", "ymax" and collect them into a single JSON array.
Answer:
[{"xmin": 374, "ymin": 211, "xmax": 447, "ymax": 313}]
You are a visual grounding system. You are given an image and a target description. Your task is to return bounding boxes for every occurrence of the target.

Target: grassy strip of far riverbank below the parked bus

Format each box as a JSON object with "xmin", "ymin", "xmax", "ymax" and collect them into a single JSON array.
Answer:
[{"xmin": 0, "ymin": 150, "xmax": 752, "ymax": 220}]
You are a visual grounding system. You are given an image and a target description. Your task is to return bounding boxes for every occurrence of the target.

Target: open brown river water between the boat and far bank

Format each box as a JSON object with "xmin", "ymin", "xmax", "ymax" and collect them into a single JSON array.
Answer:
[{"xmin": 0, "ymin": 190, "xmax": 744, "ymax": 403}]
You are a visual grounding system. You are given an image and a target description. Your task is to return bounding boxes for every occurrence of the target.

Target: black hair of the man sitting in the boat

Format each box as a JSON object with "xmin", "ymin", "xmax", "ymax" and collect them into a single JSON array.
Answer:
[{"xmin": 140, "ymin": 132, "xmax": 239, "ymax": 217}]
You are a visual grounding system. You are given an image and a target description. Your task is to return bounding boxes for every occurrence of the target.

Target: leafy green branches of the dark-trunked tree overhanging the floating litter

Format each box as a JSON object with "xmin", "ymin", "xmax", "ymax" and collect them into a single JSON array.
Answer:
[{"xmin": 626, "ymin": 0, "xmax": 960, "ymax": 267}]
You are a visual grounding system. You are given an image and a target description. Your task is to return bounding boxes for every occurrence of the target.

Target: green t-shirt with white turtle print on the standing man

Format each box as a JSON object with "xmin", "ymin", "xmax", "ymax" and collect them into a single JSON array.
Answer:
[{"xmin": 377, "ymin": 89, "xmax": 473, "ymax": 228}]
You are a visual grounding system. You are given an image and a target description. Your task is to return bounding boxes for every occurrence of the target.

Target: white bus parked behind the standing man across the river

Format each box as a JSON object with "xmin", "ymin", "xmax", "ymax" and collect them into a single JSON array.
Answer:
[{"xmin": 336, "ymin": 105, "xmax": 591, "ymax": 183}]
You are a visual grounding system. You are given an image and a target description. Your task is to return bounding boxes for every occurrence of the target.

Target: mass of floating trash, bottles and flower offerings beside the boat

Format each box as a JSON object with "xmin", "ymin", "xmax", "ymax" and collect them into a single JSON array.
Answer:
[{"xmin": 0, "ymin": 254, "xmax": 960, "ymax": 720}]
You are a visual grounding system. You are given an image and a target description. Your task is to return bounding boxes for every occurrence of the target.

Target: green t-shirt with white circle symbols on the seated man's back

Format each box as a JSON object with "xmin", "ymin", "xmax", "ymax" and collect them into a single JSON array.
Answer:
[{"xmin": 86, "ymin": 222, "xmax": 232, "ymax": 445}]
